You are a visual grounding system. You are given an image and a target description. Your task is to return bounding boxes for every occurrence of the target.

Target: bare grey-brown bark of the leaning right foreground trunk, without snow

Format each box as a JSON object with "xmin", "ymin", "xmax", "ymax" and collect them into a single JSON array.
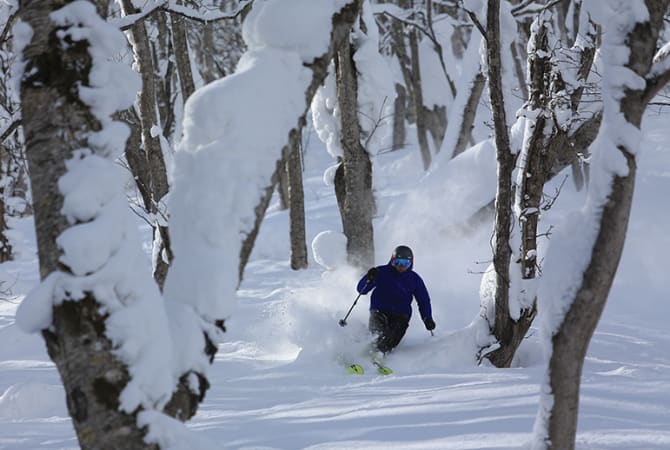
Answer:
[{"xmin": 544, "ymin": 0, "xmax": 670, "ymax": 450}]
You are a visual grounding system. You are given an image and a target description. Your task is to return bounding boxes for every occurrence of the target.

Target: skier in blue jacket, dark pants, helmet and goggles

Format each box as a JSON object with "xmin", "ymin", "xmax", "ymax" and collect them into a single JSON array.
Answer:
[{"xmin": 356, "ymin": 245, "xmax": 435, "ymax": 354}]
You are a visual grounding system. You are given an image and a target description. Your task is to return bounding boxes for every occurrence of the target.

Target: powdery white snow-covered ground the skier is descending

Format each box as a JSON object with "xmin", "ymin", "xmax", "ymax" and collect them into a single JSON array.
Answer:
[{"xmin": 0, "ymin": 111, "xmax": 670, "ymax": 450}]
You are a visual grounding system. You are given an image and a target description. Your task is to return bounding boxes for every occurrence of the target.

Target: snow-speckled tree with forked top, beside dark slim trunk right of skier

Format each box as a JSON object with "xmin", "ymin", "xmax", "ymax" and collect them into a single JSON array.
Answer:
[{"xmin": 476, "ymin": 0, "xmax": 597, "ymax": 367}]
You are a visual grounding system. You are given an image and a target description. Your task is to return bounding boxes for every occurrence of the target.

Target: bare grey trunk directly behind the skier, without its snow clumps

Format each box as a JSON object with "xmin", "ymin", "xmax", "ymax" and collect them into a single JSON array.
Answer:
[{"xmin": 335, "ymin": 29, "xmax": 374, "ymax": 267}]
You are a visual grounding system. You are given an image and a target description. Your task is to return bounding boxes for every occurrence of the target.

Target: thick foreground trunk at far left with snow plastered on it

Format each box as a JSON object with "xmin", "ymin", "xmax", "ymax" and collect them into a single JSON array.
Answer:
[{"xmin": 16, "ymin": 1, "xmax": 175, "ymax": 449}]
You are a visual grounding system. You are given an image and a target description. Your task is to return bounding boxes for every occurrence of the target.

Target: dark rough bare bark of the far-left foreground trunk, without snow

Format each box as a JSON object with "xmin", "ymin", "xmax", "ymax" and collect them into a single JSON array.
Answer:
[{"xmin": 21, "ymin": 0, "xmax": 156, "ymax": 449}]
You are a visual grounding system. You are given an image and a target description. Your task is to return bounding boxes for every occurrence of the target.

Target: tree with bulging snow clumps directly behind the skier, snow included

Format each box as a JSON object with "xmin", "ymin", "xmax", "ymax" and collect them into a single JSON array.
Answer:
[{"xmin": 311, "ymin": 1, "xmax": 395, "ymax": 268}]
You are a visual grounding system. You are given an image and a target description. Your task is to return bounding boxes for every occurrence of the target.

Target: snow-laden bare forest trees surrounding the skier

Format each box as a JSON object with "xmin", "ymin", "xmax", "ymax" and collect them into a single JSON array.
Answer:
[{"xmin": 0, "ymin": 0, "xmax": 670, "ymax": 450}]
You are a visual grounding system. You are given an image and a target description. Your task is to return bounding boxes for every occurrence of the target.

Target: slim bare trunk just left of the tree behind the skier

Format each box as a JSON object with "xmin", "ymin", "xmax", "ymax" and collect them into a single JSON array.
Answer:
[{"xmin": 287, "ymin": 127, "xmax": 307, "ymax": 270}]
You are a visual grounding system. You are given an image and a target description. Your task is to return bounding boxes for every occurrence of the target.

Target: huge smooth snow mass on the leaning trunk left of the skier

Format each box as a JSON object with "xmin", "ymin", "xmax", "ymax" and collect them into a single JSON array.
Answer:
[{"xmin": 165, "ymin": 0, "xmax": 360, "ymax": 404}]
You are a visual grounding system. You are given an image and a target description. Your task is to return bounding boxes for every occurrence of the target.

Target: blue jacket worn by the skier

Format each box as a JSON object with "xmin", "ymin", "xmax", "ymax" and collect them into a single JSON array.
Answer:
[{"xmin": 356, "ymin": 262, "xmax": 433, "ymax": 320}]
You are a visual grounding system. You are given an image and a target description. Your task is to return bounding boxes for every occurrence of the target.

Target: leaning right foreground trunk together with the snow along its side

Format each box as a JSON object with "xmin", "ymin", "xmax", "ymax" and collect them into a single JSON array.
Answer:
[{"xmin": 533, "ymin": 0, "xmax": 670, "ymax": 450}]
